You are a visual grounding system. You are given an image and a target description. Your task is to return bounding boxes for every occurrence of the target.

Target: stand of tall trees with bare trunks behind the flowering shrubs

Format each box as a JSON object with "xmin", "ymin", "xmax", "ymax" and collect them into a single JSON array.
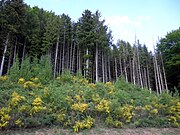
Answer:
[{"xmin": 0, "ymin": 0, "xmax": 180, "ymax": 94}]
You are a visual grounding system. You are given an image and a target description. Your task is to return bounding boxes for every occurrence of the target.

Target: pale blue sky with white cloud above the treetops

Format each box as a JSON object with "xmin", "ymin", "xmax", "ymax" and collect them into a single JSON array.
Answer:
[{"xmin": 24, "ymin": 0, "xmax": 180, "ymax": 51}]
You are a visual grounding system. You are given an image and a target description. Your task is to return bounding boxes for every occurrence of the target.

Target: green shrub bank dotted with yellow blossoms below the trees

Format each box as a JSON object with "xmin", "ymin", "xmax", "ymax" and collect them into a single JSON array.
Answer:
[{"xmin": 0, "ymin": 57, "xmax": 180, "ymax": 132}]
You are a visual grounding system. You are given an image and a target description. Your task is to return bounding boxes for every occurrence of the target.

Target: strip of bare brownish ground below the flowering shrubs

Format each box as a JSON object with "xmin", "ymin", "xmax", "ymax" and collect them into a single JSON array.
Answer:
[{"xmin": 0, "ymin": 126, "xmax": 180, "ymax": 135}]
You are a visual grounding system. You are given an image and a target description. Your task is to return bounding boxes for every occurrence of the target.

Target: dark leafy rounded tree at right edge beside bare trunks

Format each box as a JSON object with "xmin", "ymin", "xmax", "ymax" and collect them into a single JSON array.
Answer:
[{"xmin": 157, "ymin": 28, "xmax": 180, "ymax": 89}]
